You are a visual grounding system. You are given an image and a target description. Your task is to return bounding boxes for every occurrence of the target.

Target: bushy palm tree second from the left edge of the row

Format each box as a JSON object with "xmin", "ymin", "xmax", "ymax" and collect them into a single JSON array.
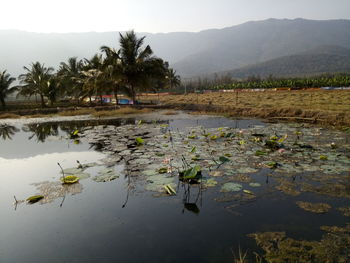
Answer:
[{"xmin": 19, "ymin": 62, "xmax": 53, "ymax": 107}]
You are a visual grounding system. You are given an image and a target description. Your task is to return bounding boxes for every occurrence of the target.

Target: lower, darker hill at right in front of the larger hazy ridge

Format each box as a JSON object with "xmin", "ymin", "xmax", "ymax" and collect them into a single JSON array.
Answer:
[{"xmin": 212, "ymin": 46, "xmax": 350, "ymax": 79}]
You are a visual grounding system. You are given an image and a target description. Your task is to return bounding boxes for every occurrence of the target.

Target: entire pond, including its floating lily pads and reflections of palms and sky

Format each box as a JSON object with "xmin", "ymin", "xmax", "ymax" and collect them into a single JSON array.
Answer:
[{"xmin": 0, "ymin": 113, "xmax": 350, "ymax": 262}]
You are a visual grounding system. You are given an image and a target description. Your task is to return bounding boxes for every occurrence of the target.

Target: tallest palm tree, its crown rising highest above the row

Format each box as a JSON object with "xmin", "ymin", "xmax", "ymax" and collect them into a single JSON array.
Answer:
[{"xmin": 119, "ymin": 31, "xmax": 164, "ymax": 101}]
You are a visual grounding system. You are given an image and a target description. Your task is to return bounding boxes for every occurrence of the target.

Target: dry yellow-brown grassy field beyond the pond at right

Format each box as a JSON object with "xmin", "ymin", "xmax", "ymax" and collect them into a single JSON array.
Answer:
[{"xmin": 141, "ymin": 90, "xmax": 350, "ymax": 126}]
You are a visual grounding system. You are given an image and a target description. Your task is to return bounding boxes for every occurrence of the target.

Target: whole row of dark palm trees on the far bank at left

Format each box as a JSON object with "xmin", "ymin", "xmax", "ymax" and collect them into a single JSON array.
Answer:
[{"xmin": 0, "ymin": 31, "xmax": 181, "ymax": 108}]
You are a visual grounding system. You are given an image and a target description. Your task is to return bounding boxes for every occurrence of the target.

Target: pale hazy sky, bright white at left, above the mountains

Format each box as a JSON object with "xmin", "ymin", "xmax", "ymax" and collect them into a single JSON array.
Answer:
[{"xmin": 0, "ymin": 0, "xmax": 350, "ymax": 32}]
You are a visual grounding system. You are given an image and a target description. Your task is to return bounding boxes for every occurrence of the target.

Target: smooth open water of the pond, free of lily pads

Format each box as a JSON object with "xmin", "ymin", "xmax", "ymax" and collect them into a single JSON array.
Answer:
[{"xmin": 0, "ymin": 118, "xmax": 349, "ymax": 262}]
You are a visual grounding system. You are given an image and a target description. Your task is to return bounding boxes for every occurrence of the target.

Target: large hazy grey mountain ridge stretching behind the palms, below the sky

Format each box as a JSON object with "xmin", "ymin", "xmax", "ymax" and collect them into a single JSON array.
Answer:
[{"xmin": 0, "ymin": 19, "xmax": 350, "ymax": 77}]
